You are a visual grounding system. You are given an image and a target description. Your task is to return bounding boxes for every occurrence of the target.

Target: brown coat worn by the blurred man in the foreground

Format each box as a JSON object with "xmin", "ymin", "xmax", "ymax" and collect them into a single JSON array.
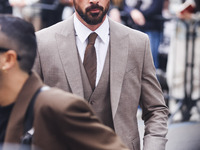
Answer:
[{"xmin": 4, "ymin": 73, "xmax": 128, "ymax": 150}]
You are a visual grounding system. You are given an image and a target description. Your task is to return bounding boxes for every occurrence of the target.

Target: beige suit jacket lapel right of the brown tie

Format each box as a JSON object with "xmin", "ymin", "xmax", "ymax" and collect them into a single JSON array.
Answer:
[{"xmin": 110, "ymin": 20, "xmax": 128, "ymax": 119}]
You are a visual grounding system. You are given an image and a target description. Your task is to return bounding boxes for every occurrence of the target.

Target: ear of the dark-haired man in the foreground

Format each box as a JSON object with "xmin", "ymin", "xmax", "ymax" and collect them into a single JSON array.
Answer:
[{"xmin": 2, "ymin": 50, "xmax": 17, "ymax": 70}]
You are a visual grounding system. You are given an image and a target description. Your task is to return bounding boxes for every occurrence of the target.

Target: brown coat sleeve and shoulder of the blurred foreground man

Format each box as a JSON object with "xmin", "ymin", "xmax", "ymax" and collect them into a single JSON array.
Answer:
[{"xmin": 34, "ymin": 90, "xmax": 127, "ymax": 150}]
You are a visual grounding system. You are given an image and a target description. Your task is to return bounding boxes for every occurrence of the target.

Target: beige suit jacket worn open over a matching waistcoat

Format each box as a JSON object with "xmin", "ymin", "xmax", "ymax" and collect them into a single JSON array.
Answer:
[{"xmin": 34, "ymin": 16, "xmax": 168, "ymax": 150}]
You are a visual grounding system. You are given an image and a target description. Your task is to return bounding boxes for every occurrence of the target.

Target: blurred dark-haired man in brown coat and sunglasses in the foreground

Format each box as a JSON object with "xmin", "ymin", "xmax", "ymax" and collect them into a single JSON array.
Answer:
[{"xmin": 0, "ymin": 15, "xmax": 127, "ymax": 150}]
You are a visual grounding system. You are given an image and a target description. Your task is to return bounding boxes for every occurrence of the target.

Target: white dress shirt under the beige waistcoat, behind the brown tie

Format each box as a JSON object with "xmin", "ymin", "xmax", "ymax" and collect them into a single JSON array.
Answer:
[{"xmin": 74, "ymin": 15, "xmax": 110, "ymax": 86}]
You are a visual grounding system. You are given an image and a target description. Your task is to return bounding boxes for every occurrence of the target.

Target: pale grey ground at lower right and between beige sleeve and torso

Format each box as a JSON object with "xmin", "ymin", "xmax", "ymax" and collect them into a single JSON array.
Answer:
[{"xmin": 138, "ymin": 107, "xmax": 200, "ymax": 150}]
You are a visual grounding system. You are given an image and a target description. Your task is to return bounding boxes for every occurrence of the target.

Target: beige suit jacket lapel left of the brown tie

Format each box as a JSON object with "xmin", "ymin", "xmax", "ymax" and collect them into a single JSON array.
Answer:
[{"xmin": 56, "ymin": 17, "xmax": 84, "ymax": 97}]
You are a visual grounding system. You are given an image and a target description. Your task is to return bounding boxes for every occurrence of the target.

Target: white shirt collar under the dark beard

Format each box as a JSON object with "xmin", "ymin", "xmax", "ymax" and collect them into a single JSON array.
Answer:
[{"xmin": 74, "ymin": 15, "xmax": 109, "ymax": 43}]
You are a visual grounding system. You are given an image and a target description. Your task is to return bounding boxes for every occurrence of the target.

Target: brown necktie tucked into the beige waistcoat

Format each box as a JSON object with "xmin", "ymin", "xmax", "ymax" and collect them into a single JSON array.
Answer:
[{"xmin": 83, "ymin": 32, "xmax": 97, "ymax": 91}]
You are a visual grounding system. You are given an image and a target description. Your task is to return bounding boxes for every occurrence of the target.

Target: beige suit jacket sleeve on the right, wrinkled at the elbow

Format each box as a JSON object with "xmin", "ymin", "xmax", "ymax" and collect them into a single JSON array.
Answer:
[{"xmin": 140, "ymin": 35, "xmax": 169, "ymax": 150}]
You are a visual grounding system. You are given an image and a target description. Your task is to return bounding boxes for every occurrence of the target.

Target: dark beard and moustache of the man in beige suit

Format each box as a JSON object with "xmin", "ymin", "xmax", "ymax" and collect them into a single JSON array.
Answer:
[{"xmin": 74, "ymin": 2, "xmax": 110, "ymax": 25}]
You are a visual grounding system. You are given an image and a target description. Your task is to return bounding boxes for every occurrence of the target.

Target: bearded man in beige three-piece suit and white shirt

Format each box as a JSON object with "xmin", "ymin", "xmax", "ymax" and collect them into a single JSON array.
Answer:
[{"xmin": 34, "ymin": 0, "xmax": 168, "ymax": 150}]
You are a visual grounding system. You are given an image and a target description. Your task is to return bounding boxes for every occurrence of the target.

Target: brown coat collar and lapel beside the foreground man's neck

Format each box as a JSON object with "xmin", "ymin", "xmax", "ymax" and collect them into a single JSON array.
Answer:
[{"xmin": 5, "ymin": 72, "xmax": 43, "ymax": 143}]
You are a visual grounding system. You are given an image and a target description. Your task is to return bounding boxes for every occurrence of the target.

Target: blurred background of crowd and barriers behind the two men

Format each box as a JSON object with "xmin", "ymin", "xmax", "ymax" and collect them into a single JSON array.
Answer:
[{"xmin": 0, "ymin": 0, "xmax": 200, "ymax": 150}]
